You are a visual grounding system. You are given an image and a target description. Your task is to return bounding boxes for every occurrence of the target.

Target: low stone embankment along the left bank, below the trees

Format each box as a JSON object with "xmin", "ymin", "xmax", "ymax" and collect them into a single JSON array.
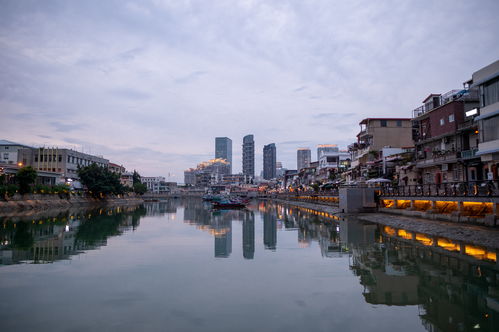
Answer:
[{"xmin": 0, "ymin": 194, "xmax": 144, "ymax": 213}]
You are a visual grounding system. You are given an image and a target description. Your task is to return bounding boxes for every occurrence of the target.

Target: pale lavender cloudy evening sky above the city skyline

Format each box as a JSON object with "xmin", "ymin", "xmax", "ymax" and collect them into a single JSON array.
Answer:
[{"xmin": 0, "ymin": 0, "xmax": 499, "ymax": 182}]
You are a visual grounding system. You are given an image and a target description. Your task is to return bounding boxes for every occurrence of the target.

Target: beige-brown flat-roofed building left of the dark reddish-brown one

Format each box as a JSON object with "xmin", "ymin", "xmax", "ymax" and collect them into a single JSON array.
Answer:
[{"xmin": 348, "ymin": 118, "xmax": 414, "ymax": 179}]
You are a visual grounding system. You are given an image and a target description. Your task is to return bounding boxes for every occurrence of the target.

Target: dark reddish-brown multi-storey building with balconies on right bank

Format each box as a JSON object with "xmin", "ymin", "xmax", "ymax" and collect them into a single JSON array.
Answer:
[{"xmin": 407, "ymin": 89, "xmax": 482, "ymax": 184}]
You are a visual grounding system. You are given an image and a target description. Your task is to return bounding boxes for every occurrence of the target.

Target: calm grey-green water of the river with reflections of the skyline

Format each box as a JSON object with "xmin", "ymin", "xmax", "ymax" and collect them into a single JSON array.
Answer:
[{"xmin": 0, "ymin": 200, "xmax": 499, "ymax": 331}]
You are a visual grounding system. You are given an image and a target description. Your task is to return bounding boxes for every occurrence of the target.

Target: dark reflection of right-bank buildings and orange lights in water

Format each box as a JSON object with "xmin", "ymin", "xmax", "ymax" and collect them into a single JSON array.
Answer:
[{"xmin": 259, "ymin": 204, "xmax": 499, "ymax": 331}]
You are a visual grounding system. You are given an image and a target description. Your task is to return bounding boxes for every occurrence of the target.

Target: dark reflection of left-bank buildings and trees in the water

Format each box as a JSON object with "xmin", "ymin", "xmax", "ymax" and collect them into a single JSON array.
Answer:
[{"xmin": 0, "ymin": 206, "xmax": 146, "ymax": 265}]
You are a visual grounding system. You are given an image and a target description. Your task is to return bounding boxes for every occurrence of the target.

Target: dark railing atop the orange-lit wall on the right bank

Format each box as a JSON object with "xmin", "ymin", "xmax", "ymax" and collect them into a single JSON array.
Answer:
[{"xmin": 381, "ymin": 181, "xmax": 499, "ymax": 197}]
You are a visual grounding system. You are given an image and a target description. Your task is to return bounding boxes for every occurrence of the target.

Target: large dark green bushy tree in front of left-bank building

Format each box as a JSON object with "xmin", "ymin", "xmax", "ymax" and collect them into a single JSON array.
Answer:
[{"xmin": 78, "ymin": 163, "xmax": 124, "ymax": 197}]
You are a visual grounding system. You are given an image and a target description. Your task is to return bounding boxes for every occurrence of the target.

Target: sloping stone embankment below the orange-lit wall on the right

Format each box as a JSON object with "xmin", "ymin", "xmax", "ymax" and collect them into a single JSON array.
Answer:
[{"xmin": 272, "ymin": 199, "xmax": 499, "ymax": 250}]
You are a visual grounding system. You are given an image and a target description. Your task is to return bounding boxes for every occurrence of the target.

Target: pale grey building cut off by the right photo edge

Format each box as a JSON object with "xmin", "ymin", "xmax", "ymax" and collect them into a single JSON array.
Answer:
[{"xmin": 471, "ymin": 60, "xmax": 499, "ymax": 180}]
